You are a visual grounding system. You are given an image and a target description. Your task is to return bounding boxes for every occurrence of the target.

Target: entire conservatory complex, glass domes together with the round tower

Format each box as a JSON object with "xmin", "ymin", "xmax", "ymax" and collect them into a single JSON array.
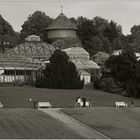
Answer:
[{"xmin": 0, "ymin": 13, "xmax": 100, "ymax": 85}]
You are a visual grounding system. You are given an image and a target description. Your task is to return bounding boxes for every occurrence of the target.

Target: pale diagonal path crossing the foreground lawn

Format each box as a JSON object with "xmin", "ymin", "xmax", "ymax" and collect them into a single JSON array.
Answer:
[{"xmin": 39, "ymin": 109, "xmax": 109, "ymax": 139}]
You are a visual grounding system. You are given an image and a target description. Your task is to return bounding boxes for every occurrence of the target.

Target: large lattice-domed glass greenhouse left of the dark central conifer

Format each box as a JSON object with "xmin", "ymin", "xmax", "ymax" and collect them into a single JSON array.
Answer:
[{"xmin": 0, "ymin": 35, "xmax": 55, "ymax": 85}]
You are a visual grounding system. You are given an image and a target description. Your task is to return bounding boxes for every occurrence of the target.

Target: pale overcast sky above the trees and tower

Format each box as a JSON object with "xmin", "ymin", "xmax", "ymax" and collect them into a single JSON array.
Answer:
[{"xmin": 0, "ymin": 0, "xmax": 140, "ymax": 34}]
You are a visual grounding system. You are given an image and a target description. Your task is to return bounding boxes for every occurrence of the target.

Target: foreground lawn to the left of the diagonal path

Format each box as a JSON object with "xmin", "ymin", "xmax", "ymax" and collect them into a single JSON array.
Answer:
[{"xmin": 0, "ymin": 109, "xmax": 81, "ymax": 139}]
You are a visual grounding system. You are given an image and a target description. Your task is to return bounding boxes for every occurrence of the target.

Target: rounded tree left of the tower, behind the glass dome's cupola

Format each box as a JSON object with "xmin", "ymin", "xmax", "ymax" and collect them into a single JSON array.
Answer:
[{"xmin": 21, "ymin": 11, "xmax": 53, "ymax": 41}]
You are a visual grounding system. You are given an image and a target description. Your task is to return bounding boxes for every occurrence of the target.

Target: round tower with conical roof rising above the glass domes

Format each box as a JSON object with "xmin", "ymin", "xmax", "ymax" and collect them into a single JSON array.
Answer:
[{"xmin": 46, "ymin": 13, "xmax": 78, "ymax": 42}]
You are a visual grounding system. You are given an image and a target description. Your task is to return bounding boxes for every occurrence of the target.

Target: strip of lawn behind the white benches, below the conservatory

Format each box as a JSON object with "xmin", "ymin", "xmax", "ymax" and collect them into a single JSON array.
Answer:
[{"xmin": 0, "ymin": 87, "xmax": 140, "ymax": 108}]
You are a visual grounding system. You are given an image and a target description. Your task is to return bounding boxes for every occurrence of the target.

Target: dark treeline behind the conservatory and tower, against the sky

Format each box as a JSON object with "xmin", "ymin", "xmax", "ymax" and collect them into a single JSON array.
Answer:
[{"xmin": 0, "ymin": 11, "xmax": 140, "ymax": 57}]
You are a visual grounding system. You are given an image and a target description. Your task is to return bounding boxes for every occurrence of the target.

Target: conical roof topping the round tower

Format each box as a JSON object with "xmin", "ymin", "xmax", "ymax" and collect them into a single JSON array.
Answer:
[{"xmin": 47, "ymin": 13, "xmax": 77, "ymax": 30}]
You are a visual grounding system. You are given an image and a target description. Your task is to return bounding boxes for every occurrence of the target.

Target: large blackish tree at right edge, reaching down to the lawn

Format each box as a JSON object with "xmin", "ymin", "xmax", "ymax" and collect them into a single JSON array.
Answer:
[{"xmin": 103, "ymin": 49, "xmax": 140, "ymax": 97}]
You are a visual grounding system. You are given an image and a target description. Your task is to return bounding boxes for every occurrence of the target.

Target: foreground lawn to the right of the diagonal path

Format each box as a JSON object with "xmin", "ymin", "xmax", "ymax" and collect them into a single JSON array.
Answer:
[{"xmin": 62, "ymin": 107, "xmax": 140, "ymax": 139}]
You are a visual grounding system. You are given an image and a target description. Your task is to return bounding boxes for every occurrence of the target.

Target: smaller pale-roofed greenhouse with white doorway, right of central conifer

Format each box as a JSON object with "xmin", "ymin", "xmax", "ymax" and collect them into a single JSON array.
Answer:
[{"xmin": 63, "ymin": 47, "xmax": 100, "ymax": 84}]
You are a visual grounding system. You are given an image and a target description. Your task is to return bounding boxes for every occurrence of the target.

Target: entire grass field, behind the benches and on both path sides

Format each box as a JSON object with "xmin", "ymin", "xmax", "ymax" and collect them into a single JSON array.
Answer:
[{"xmin": 0, "ymin": 87, "xmax": 140, "ymax": 139}]
